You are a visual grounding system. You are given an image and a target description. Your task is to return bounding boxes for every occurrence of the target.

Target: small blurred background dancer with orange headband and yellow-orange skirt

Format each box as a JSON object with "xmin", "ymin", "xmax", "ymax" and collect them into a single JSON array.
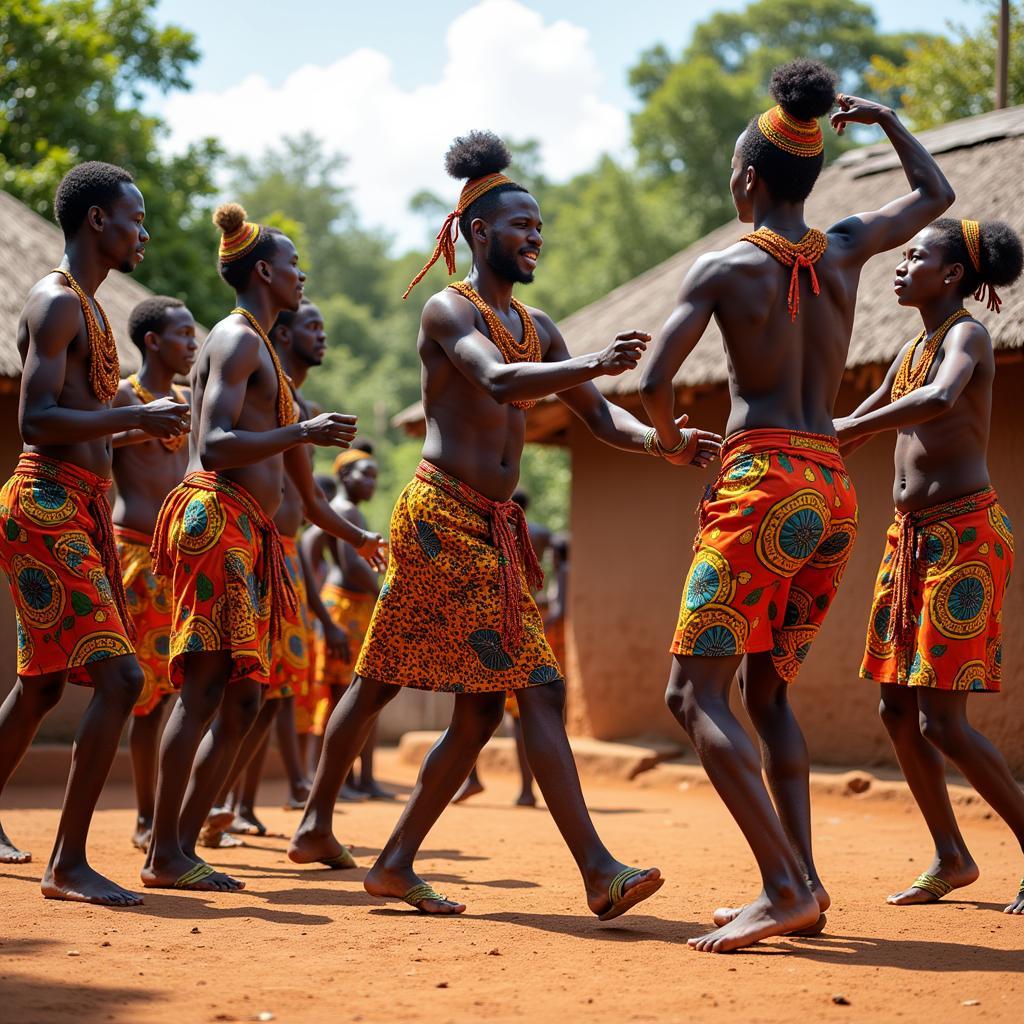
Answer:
[{"xmin": 302, "ymin": 438, "xmax": 391, "ymax": 800}]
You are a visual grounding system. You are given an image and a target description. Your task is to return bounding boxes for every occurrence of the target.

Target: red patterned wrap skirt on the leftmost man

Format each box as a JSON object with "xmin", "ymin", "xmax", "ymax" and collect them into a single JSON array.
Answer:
[{"xmin": 0, "ymin": 453, "xmax": 135, "ymax": 685}]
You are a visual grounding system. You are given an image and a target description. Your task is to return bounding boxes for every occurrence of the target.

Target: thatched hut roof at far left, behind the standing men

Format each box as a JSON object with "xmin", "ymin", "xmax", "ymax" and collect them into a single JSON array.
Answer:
[{"xmin": 0, "ymin": 191, "xmax": 153, "ymax": 378}]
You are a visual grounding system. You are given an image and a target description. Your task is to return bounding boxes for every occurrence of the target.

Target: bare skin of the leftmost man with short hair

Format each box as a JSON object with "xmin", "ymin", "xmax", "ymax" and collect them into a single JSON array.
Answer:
[{"xmin": 0, "ymin": 184, "xmax": 188, "ymax": 906}]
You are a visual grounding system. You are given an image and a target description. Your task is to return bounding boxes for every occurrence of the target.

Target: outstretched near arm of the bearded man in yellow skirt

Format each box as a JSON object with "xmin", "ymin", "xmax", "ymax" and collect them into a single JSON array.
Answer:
[{"xmin": 423, "ymin": 289, "xmax": 650, "ymax": 404}]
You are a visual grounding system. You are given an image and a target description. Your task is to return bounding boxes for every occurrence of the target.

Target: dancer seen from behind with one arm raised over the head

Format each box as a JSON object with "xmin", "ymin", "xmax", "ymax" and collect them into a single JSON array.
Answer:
[{"xmin": 641, "ymin": 60, "xmax": 953, "ymax": 952}]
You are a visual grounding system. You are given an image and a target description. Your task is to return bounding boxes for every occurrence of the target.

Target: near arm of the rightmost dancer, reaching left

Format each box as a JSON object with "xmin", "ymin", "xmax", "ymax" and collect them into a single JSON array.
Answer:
[{"xmin": 839, "ymin": 324, "xmax": 990, "ymax": 442}]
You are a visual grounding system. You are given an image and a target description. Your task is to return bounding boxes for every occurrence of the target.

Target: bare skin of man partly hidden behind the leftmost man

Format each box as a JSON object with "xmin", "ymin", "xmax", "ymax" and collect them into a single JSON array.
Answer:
[{"xmin": 113, "ymin": 306, "xmax": 199, "ymax": 851}]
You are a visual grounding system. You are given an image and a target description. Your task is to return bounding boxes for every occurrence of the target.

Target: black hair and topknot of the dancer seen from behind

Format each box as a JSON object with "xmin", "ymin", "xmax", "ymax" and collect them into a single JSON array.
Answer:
[{"xmin": 739, "ymin": 58, "xmax": 839, "ymax": 203}]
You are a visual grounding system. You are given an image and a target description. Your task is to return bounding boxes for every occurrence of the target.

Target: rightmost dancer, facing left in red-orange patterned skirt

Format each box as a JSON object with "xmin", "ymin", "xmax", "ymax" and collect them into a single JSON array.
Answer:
[{"xmin": 836, "ymin": 217, "xmax": 1024, "ymax": 914}]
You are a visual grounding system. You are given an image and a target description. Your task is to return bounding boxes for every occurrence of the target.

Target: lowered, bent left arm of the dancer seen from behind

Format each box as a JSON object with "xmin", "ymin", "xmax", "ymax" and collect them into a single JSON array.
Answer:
[{"xmin": 640, "ymin": 253, "xmax": 718, "ymax": 449}]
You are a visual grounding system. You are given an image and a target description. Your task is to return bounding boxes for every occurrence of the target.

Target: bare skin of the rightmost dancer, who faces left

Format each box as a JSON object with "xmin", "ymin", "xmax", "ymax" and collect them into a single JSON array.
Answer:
[{"xmin": 836, "ymin": 228, "xmax": 1024, "ymax": 914}]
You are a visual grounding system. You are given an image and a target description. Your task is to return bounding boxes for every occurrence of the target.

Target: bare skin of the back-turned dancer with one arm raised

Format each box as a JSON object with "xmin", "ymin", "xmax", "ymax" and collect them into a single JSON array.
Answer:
[{"xmin": 640, "ymin": 95, "xmax": 953, "ymax": 952}]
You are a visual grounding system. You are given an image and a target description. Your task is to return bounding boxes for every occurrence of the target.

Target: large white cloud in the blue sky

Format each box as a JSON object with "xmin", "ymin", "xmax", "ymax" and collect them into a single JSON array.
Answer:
[{"xmin": 163, "ymin": 0, "xmax": 628, "ymax": 252}]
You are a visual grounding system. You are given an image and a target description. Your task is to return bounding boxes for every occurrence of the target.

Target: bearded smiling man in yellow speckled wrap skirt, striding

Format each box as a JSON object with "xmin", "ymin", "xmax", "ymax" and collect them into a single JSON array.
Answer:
[{"xmin": 289, "ymin": 132, "xmax": 719, "ymax": 920}]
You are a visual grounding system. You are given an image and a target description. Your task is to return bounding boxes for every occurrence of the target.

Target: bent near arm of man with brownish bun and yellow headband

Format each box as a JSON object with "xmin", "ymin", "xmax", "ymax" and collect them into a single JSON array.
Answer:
[{"xmin": 200, "ymin": 328, "xmax": 308, "ymax": 471}]
